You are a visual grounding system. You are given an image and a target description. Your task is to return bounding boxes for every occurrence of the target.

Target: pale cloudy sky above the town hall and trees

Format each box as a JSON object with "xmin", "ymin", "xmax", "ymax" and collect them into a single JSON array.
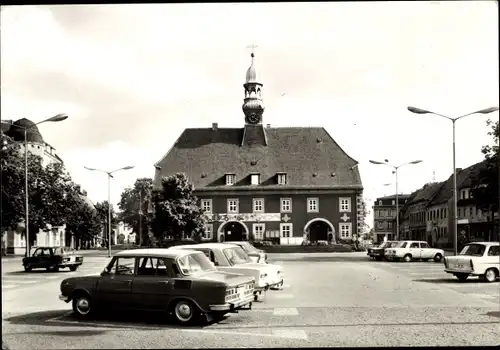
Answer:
[{"xmin": 0, "ymin": 1, "xmax": 499, "ymax": 230}]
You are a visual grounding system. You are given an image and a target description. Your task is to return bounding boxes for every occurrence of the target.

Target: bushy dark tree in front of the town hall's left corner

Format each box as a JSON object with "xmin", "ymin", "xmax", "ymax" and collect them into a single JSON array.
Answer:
[{"xmin": 151, "ymin": 173, "xmax": 205, "ymax": 242}]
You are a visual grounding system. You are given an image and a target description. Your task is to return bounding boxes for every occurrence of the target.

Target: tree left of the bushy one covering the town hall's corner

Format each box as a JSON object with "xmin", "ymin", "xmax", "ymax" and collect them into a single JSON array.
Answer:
[{"xmin": 118, "ymin": 178, "xmax": 153, "ymax": 244}]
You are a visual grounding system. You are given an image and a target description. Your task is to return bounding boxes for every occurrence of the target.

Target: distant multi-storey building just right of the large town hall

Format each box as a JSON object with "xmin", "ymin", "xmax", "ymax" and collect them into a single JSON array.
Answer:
[{"xmin": 373, "ymin": 194, "xmax": 410, "ymax": 243}]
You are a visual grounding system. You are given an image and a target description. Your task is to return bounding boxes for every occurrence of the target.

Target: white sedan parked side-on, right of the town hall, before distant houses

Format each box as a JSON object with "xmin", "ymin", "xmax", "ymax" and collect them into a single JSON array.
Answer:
[{"xmin": 384, "ymin": 241, "xmax": 444, "ymax": 262}]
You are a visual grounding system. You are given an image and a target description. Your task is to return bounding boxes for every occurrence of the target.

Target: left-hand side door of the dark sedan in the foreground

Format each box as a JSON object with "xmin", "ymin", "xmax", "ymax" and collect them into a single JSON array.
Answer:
[{"xmin": 96, "ymin": 256, "xmax": 141, "ymax": 309}]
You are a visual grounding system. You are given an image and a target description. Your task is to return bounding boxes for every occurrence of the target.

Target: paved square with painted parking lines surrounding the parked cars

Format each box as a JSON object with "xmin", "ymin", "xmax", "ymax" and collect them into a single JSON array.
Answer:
[{"xmin": 2, "ymin": 254, "xmax": 500, "ymax": 349}]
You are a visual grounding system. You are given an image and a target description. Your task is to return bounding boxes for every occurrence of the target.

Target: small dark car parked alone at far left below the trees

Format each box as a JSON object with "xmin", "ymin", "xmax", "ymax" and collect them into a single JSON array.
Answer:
[{"xmin": 23, "ymin": 247, "xmax": 83, "ymax": 272}]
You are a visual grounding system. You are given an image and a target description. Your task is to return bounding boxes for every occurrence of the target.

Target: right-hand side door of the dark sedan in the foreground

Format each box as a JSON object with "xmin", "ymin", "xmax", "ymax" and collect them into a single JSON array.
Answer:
[{"xmin": 132, "ymin": 257, "xmax": 173, "ymax": 310}]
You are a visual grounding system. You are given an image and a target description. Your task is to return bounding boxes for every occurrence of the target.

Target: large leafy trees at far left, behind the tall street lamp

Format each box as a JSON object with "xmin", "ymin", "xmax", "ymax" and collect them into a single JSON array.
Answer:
[{"xmin": 1, "ymin": 134, "xmax": 102, "ymax": 243}]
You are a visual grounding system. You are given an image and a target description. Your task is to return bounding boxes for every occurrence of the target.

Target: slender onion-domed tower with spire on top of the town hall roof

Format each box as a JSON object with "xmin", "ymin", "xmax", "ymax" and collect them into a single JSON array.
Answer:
[{"xmin": 242, "ymin": 45, "xmax": 264, "ymax": 125}]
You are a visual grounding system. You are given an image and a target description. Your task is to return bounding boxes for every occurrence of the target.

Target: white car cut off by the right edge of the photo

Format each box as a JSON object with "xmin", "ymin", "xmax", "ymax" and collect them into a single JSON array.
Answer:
[{"xmin": 444, "ymin": 242, "xmax": 500, "ymax": 282}]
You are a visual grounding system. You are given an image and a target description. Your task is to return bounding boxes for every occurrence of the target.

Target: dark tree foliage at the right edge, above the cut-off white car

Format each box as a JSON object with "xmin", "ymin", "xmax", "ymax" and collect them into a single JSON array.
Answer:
[{"xmin": 471, "ymin": 120, "xmax": 500, "ymax": 212}]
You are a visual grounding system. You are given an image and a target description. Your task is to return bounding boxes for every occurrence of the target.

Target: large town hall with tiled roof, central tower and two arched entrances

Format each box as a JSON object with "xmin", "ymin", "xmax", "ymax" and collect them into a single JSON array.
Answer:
[{"xmin": 154, "ymin": 53, "xmax": 363, "ymax": 244}]
